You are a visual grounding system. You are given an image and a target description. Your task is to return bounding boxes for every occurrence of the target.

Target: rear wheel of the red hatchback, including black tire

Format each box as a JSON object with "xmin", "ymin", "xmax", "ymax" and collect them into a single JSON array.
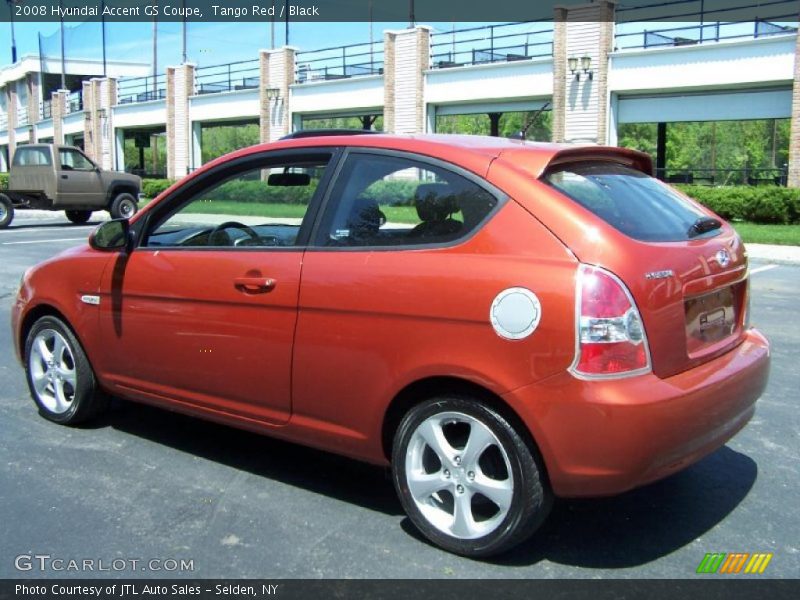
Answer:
[{"xmin": 392, "ymin": 396, "xmax": 552, "ymax": 558}]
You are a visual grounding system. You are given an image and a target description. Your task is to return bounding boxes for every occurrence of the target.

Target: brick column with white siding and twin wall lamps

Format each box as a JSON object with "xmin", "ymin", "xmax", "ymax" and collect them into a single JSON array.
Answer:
[{"xmin": 553, "ymin": 0, "xmax": 616, "ymax": 144}]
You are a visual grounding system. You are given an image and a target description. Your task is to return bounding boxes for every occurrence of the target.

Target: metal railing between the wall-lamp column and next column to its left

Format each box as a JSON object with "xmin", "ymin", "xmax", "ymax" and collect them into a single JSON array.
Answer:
[{"xmin": 431, "ymin": 21, "xmax": 553, "ymax": 69}]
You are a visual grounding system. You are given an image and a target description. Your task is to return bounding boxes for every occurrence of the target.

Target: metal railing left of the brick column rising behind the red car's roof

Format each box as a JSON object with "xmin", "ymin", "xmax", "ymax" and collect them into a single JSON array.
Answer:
[{"xmin": 295, "ymin": 40, "xmax": 383, "ymax": 83}]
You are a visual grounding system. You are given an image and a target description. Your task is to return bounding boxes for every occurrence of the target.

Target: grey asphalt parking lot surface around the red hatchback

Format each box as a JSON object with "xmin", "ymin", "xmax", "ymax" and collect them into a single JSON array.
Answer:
[{"xmin": 0, "ymin": 212, "xmax": 800, "ymax": 578}]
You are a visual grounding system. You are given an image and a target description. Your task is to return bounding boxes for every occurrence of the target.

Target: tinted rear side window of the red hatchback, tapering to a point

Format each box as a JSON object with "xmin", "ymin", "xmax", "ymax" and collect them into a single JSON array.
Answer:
[{"xmin": 317, "ymin": 153, "xmax": 497, "ymax": 247}]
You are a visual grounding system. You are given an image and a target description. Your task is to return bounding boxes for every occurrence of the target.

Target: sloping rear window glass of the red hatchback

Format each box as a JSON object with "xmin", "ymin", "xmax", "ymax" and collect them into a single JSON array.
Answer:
[{"xmin": 543, "ymin": 161, "xmax": 721, "ymax": 242}]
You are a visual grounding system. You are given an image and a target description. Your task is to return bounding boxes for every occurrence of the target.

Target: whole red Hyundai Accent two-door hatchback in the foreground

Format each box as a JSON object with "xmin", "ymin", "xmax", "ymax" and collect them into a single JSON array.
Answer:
[{"xmin": 13, "ymin": 135, "xmax": 769, "ymax": 556}]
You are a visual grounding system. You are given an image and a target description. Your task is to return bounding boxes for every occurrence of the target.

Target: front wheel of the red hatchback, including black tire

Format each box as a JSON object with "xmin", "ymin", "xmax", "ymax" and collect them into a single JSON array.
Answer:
[{"xmin": 25, "ymin": 316, "xmax": 108, "ymax": 425}]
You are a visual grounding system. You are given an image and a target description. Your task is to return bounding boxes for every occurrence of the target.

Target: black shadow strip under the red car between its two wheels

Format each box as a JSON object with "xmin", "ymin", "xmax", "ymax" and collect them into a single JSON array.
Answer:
[{"xmin": 90, "ymin": 400, "xmax": 404, "ymax": 516}]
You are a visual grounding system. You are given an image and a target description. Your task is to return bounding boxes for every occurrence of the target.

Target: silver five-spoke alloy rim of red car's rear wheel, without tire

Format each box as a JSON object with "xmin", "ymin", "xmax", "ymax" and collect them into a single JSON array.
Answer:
[{"xmin": 405, "ymin": 412, "xmax": 514, "ymax": 540}]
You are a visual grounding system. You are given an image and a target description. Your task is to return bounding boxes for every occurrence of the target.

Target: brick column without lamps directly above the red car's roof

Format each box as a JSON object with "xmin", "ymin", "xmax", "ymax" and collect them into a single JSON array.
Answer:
[{"xmin": 383, "ymin": 26, "xmax": 431, "ymax": 133}]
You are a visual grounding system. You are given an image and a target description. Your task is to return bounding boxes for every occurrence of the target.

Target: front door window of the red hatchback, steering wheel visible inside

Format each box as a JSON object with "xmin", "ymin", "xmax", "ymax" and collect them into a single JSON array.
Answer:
[{"xmin": 143, "ymin": 157, "xmax": 329, "ymax": 248}]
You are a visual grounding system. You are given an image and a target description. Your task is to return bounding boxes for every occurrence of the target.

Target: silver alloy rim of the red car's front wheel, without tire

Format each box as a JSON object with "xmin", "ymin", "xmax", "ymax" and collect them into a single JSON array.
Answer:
[{"xmin": 28, "ymin": 329, "xmax": 78, "ymax": 414}]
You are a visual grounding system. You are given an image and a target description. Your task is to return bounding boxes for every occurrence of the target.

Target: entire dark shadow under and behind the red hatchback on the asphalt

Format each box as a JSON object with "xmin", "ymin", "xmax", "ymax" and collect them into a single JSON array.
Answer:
[{"xmin": 92, "ymin": 401, "xmax": 758, "ymax": 569}]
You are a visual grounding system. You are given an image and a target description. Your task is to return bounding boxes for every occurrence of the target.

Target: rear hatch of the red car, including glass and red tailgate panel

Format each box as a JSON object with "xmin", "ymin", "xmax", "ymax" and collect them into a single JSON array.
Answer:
[{"xmin": 542, "ymin": 157, "xmax": 748, "ymax": 377}]
